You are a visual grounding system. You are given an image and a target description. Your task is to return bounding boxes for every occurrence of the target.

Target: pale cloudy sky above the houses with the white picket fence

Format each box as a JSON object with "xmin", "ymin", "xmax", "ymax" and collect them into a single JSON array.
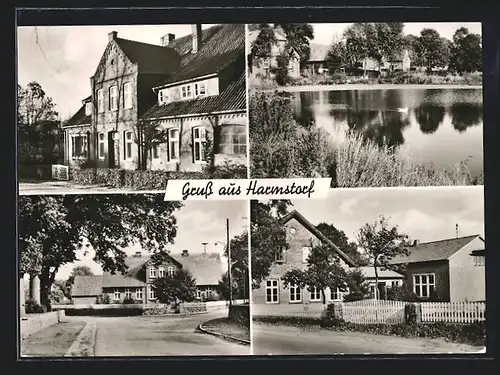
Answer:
[{"xmin": 292, "ymin": 186, "xmax": 484, "ymax": 242}]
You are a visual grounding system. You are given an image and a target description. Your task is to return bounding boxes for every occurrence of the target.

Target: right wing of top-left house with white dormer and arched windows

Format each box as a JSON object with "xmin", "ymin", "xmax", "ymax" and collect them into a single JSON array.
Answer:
[{"xmin": 142, "ymin": 25, "xmax": 247, "ymax": 171}]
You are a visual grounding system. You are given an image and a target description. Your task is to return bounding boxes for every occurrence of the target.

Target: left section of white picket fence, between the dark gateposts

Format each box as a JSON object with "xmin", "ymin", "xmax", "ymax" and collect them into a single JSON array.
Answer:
[{"xmin": 342, "ymin": 299, "xmax": 406, "ymax": 324}]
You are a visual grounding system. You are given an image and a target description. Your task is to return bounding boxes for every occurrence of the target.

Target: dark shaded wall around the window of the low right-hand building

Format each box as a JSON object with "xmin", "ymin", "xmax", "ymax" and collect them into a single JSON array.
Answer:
[{"xmin": 405, "ymin": 260, "xmax": 450, "ymax": 302}]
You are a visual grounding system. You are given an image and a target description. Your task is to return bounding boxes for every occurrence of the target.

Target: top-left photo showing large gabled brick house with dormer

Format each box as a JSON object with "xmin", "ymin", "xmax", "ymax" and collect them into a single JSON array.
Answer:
[{"xmin": 17, "ymin": 24, "xmax": 248, "ymax": 194}]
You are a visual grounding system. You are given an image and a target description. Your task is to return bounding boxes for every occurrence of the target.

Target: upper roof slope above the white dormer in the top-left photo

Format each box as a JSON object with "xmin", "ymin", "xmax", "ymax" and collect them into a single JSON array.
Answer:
[{"xmin": 154, "ymin": 24, "xmax": 245, "ymax": 87}]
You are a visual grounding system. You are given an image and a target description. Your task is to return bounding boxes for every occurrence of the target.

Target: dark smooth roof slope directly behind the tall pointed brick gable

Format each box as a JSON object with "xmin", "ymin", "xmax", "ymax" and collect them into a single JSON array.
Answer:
[{"xmin": 115, "ymin": 38, "xmax": 181, "ymax": 74}]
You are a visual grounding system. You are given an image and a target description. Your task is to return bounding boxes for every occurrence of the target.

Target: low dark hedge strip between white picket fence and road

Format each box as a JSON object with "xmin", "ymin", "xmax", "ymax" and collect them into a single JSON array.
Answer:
[{"xmin": 253, "ymin": 316, "xmax": 486, "ymax": 345}]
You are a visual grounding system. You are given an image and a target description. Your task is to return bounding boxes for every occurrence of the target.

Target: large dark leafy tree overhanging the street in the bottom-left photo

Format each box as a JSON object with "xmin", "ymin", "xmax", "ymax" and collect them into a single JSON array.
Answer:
[{"xmin": 18, "ymin": 194, "xmax": 182, "ymax": 305}]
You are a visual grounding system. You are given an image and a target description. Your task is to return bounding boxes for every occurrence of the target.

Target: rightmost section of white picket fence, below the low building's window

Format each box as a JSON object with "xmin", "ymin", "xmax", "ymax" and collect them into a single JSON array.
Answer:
[{"xmin": 420, "ymin": 302, "xmax": 486, "ymax": 323}]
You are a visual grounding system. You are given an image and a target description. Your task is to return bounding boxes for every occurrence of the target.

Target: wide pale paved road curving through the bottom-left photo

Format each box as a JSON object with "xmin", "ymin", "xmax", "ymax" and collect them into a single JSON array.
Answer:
[{"xmin": 87, "ymin": 314, "xmax": 250, "ymax": 356}]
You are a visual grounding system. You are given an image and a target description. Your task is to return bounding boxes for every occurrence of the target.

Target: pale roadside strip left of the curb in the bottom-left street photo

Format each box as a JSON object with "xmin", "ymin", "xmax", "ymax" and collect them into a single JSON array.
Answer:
[{"xmin": 21, "ymin": 321, "xmax": 85, "ymax": 357}]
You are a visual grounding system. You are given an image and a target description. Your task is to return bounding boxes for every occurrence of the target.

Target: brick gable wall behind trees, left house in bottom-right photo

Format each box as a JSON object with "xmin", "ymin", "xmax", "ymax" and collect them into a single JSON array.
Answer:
[{"xmin": 252, "ymin": 219, "xmax": 348, "ymax": 304}]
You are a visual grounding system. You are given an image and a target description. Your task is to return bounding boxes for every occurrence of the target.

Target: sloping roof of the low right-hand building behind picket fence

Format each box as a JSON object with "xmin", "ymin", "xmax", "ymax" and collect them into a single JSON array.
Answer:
[{"xmin": 390, "ymin": 234, "xmax": 482, "ymax": 264}]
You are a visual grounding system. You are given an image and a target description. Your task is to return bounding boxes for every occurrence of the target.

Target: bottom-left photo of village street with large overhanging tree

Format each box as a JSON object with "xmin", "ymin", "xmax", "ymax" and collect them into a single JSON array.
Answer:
[{"xmin": 18, "ymin": 194, "xmax": 251, "ymax": 358}]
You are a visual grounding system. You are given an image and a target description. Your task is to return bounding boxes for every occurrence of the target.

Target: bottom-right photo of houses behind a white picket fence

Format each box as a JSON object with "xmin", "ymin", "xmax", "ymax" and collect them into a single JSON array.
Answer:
[{"xmin": 251, "ymin": 186, "xmax": 486, "ymax": 355}]
